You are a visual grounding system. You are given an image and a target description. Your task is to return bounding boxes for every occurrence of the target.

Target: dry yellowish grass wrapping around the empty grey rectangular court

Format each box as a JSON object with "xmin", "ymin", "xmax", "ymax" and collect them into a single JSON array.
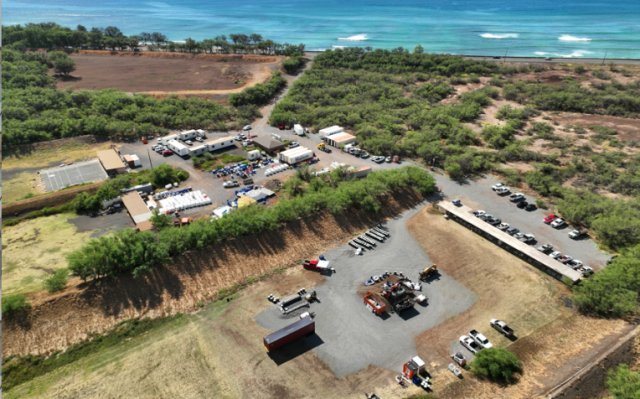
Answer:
[{"xmin": 2, "ymin": 141, "xmax": 110, "ymax": 204}]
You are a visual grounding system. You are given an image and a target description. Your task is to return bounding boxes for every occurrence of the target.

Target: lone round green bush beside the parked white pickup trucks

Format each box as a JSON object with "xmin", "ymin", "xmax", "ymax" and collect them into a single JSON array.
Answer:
[{"xmin": 471, "ymin": 348, "xmax": 522, "ymax": 382}]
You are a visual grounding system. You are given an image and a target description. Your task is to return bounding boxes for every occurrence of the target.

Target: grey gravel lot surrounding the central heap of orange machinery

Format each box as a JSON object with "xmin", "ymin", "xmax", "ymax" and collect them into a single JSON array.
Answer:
[{"xmin": 255, "ymin": 204, "xmax": 478, "ymax": 378}]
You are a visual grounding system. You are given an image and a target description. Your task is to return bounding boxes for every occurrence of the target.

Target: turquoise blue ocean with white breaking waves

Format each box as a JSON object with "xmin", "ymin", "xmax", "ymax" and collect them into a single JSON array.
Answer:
[{"xmin": 2, "ymin": 0, "xmax": 640, "ymax": 58}]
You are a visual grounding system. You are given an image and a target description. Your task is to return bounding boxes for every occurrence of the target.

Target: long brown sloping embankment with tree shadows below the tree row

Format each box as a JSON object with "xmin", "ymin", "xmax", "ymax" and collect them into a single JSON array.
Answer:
[{"xmin": 2, "ymin": 190, "xmax": 422, "ymax": 356}]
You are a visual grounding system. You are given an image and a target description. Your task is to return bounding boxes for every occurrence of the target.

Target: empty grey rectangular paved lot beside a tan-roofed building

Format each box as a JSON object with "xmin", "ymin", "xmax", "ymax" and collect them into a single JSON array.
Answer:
[{"xmin": 40, "ymin": 160, "xmax": 107, "ymax": 192}]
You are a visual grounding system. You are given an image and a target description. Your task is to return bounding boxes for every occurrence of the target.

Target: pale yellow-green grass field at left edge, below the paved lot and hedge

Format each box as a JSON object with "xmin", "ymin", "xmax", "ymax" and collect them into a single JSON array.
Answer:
[{"xmin": 2, "ymin": 213, "xmax": 91, "ymax": 295}]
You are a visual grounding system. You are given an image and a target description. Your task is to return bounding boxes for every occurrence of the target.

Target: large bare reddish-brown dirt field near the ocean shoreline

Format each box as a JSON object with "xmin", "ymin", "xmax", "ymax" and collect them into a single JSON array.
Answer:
[{"xmin": 52, "ymin": 51, "xmax": 281, "ymax": 94}]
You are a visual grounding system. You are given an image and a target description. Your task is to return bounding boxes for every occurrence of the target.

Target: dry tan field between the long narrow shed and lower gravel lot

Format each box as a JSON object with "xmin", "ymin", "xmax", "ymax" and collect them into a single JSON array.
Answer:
[{"xmin": 407, "ymin": 205, "xmax": 632, "ymax": 399}]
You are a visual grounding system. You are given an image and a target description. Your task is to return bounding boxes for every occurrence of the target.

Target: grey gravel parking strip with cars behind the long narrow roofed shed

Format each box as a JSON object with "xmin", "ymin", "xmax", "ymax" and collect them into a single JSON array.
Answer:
[{"xmin": 434, "ymin": 174, "xmax": 610, "ymax": 269}]
